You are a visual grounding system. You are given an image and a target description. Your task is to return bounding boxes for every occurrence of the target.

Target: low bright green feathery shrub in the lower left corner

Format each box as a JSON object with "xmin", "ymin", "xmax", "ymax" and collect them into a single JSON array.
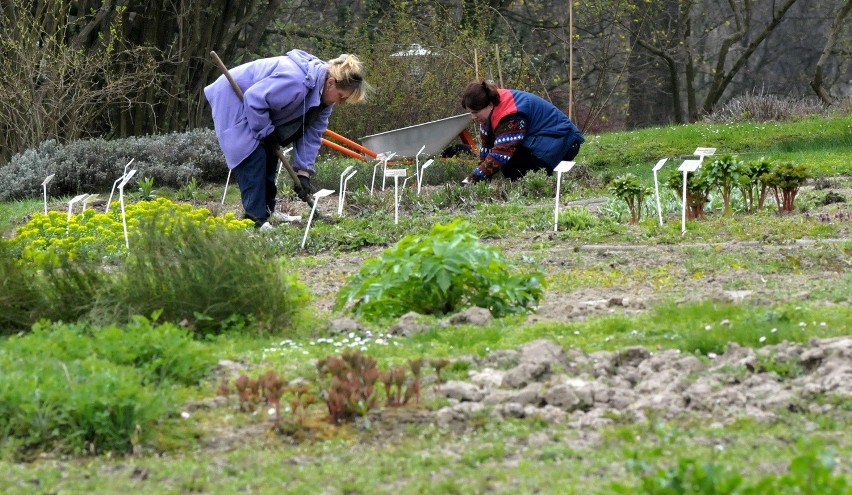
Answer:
[{"xmin": 0, "ymin": 318, "xmax": 213, "ymax": 457}]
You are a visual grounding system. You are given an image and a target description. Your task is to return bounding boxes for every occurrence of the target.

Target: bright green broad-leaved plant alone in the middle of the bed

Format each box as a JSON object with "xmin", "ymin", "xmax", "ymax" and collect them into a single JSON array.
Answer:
[{"xmin": 336, "ymin": 219, "xmax": 543, "ymax": 321}]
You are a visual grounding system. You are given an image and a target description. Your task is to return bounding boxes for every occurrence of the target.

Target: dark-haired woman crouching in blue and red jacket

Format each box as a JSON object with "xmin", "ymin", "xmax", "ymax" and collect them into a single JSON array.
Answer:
[{"xmin": 462, "ymin": 81, "xmax": 585, "ymax": 184}]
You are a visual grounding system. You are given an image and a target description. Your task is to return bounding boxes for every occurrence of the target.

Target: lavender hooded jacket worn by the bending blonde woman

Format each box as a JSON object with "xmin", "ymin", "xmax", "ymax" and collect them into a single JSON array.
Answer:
[{"xmin": 204, "ymin": 50, "xmax": 333, "ymax": 175}]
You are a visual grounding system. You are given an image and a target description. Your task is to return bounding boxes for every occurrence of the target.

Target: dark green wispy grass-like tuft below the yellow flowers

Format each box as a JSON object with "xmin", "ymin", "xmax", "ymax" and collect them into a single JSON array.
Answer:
[{"xmin": 92, "ymin": 217, "xmax": 307, "ymax": 334}]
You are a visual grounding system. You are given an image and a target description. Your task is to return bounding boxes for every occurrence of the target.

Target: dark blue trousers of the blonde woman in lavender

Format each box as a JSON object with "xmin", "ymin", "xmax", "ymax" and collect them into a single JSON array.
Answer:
[{"xmin": 234, "ymin": 143, "xmax": 278, "ymax": 227}]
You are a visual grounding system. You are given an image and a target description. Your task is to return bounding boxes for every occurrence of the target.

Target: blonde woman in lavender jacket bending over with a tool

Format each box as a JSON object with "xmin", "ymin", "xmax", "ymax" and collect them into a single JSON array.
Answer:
[{"xmin": 204, "ymin": 50, "xmax": 370, "ymax": 228}]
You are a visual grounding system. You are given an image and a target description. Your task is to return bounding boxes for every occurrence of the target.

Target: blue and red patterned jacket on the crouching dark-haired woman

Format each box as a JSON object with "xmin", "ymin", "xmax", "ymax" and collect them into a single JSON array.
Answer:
[{"xmin": 471, "ymin": 89, "xmax": 586, "ymax": 180}]
